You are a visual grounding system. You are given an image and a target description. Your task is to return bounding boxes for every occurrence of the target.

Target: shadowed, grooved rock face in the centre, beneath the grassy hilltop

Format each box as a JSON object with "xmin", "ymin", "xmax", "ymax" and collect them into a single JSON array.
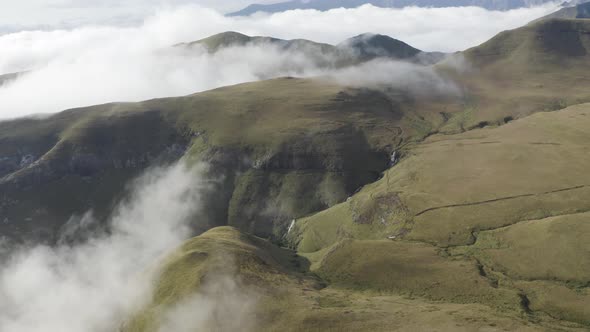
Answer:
[{"xmin": 194, "ymin": 128, "xmax": 390, "ymax": 241}]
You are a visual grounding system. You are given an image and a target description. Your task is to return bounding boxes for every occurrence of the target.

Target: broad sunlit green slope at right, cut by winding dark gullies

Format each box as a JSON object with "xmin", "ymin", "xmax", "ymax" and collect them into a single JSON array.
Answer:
[{"xmin": 289, "ymin": 104, "xmax": 590, "ymax": 324}]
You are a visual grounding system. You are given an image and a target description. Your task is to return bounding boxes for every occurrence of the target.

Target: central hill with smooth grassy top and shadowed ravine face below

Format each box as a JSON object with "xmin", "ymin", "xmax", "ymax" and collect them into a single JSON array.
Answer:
[{"xmin": 151, "ymin": 79, "xmax": 402, "ymax": 236}]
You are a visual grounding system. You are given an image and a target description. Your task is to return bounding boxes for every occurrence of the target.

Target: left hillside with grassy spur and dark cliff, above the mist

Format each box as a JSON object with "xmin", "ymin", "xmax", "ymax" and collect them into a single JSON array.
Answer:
[{"xmin": 0, "ymin": 107, "xmax": 190, "ymax": 242}]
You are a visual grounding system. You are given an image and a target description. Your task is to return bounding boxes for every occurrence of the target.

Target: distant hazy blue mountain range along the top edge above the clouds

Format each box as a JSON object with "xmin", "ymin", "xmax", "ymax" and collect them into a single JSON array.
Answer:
[{"xmin": 228, "ymin": 0, "xmax": 550, "ymax": 16}]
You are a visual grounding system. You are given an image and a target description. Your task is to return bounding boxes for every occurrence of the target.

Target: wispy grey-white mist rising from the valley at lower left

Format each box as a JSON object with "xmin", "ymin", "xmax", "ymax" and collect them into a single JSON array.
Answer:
[{"xmin": 0, "ymin": 163, "xmax": 212, "ymax": 332}]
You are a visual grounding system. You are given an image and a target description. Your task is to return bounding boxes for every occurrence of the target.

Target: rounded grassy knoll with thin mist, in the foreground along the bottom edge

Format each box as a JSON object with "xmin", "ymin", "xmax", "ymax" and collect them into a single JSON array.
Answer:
[{"xmin": 122, "ymin": 227, "xmax": 567, "ymax": 332}]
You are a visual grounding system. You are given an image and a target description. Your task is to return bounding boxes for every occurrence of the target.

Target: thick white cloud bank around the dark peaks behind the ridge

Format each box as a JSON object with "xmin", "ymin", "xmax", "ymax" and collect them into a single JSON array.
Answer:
[{"xmin": 0, "ymin": 5, "xmax": 555, "ymax": 119}]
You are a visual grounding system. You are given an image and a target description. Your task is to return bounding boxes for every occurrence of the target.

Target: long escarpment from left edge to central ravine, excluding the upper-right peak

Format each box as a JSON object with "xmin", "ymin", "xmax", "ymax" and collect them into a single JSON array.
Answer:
[{"xmin": 0, "ymin": 79, "xmax": 401, "ymax": 241}]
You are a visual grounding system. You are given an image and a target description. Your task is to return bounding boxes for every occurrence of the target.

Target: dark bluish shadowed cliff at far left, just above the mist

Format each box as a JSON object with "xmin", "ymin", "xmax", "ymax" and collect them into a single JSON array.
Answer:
[{"xmin": 0, "ymin": 142, "xmax": 192, "ymax": 242}]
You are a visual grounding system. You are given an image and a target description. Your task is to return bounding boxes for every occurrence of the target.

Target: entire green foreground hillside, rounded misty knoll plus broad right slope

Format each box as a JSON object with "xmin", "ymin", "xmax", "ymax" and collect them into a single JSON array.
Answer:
[{"xmin": 123, "ymin": 104, "xmax": 590, "ymax": 332}]
